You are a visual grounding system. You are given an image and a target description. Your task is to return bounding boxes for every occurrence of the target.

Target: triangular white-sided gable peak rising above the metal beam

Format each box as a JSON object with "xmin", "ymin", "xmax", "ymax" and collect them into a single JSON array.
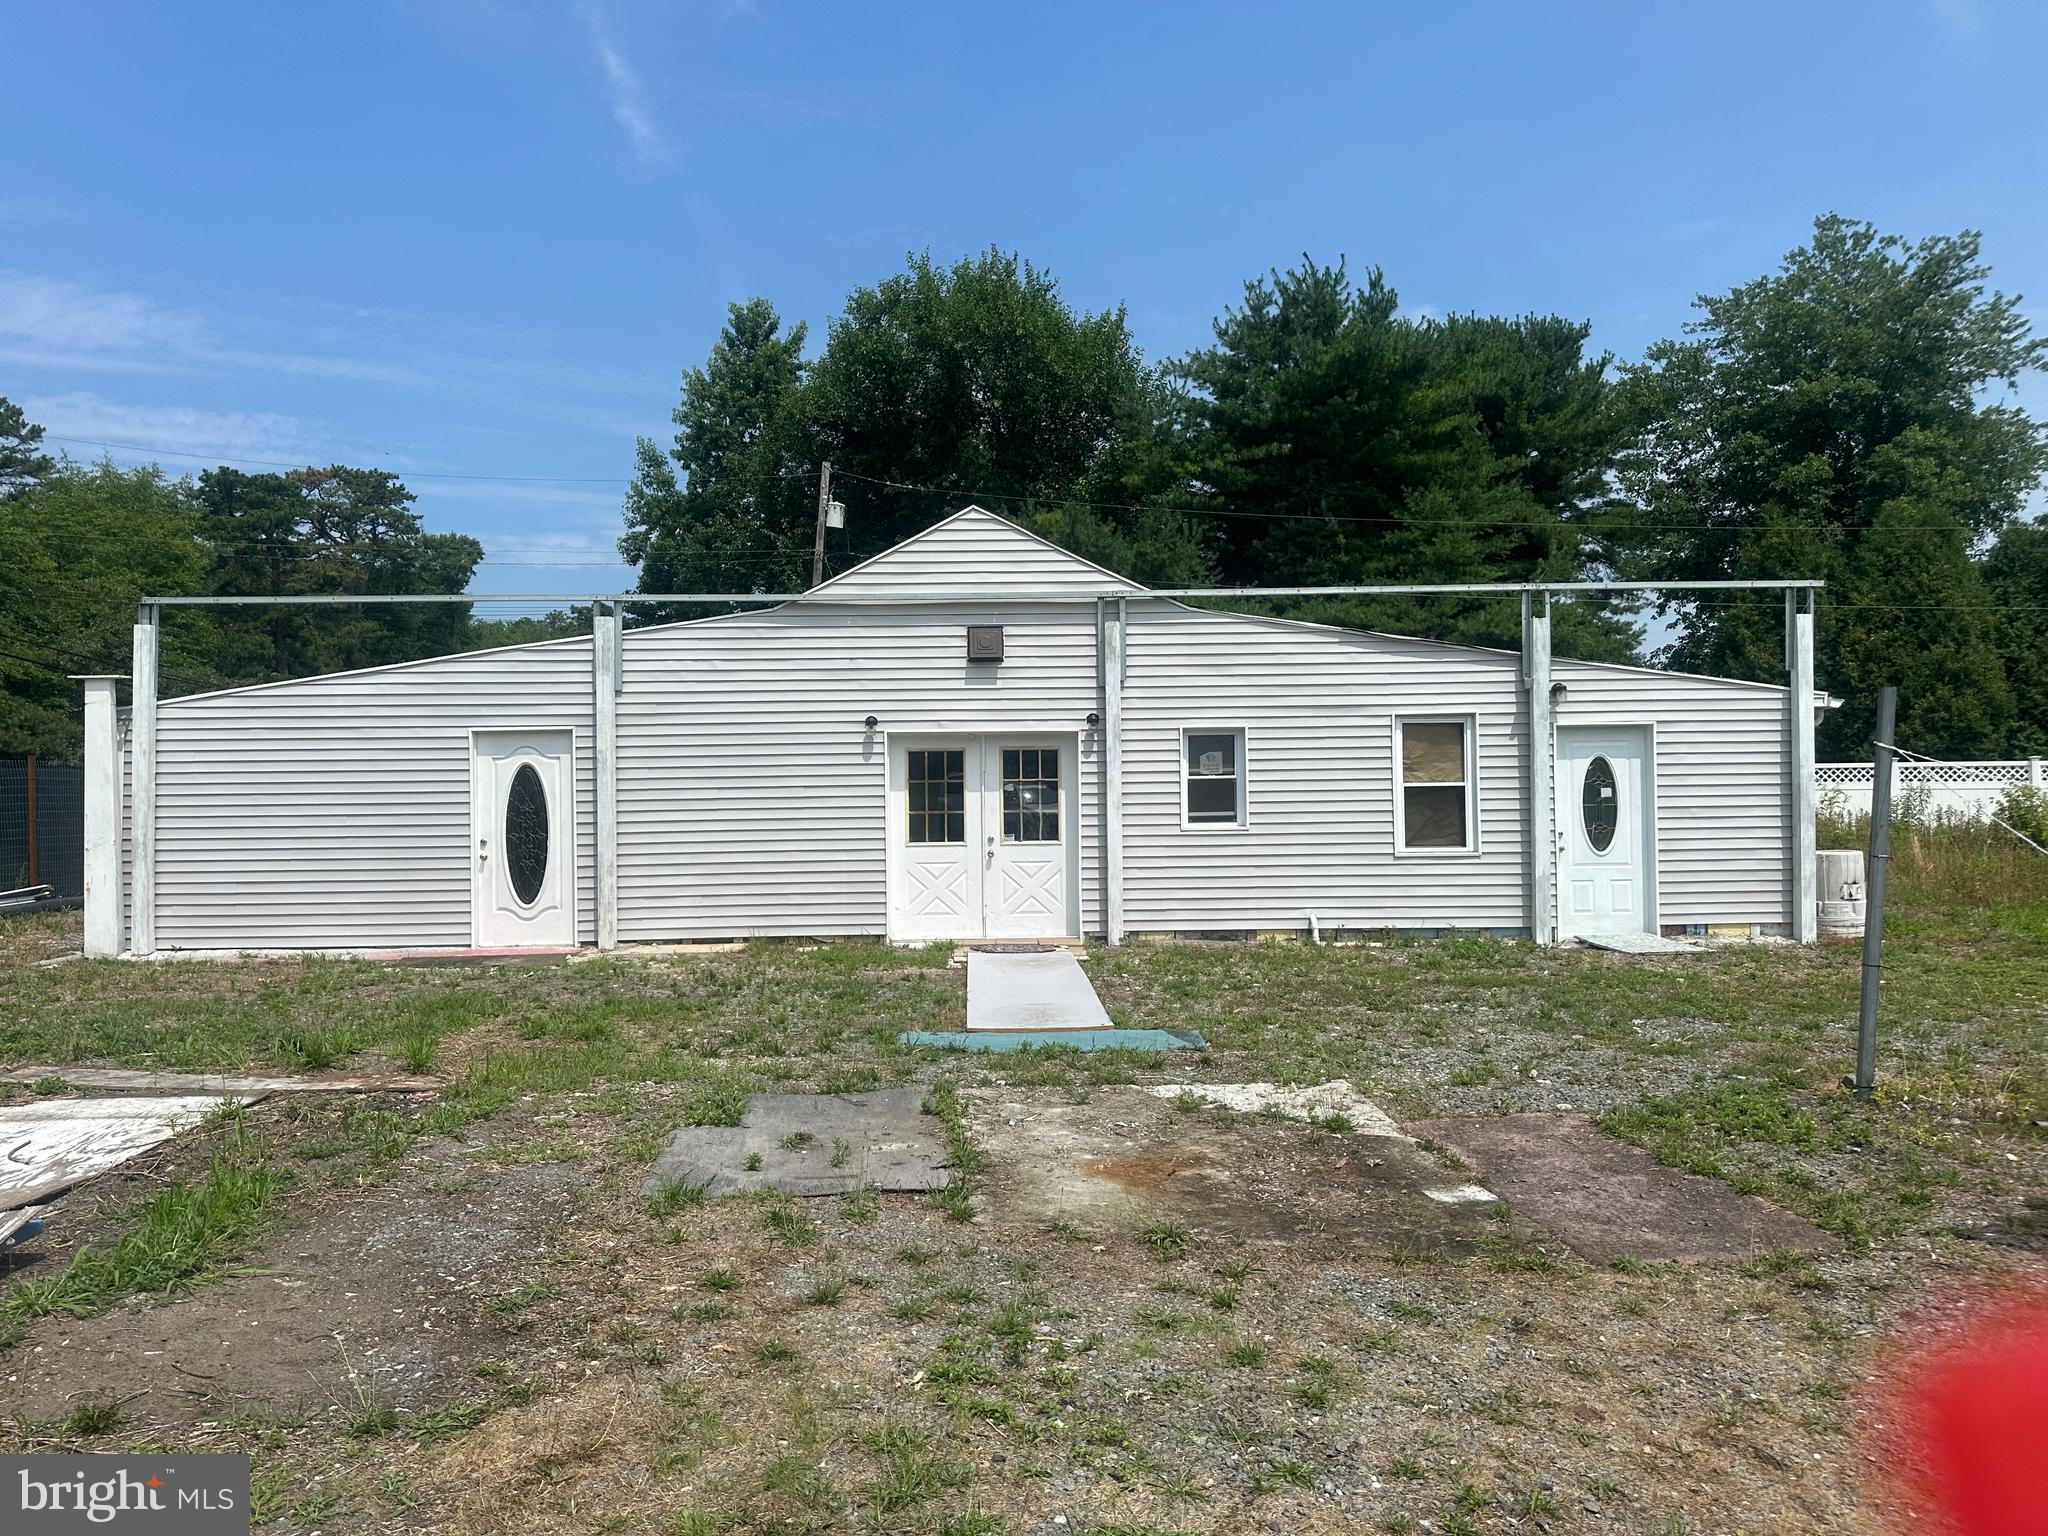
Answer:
[{"xmin": 805, "ymin": 506, "xmax": 1139, "ymax": 598}]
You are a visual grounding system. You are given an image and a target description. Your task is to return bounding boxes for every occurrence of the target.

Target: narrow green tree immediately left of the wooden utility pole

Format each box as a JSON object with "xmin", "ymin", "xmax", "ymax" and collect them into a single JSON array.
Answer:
[{"xmin": 618, "ymin": 299, "xmax": 817, "ymax": 616}]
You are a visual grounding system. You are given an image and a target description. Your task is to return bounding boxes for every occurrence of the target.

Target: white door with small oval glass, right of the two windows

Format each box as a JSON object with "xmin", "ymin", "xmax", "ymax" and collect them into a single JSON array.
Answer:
[{"xmin": 1556, "ymin": 725, "xmax": 1657, "ymax": 938}]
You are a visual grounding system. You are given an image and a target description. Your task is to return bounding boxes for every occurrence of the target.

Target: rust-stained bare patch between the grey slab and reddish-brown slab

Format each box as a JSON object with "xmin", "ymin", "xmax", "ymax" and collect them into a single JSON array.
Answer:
[{"xmin": 967, "ymin": 1087, "xmax": 1491, "ymax": 1253}]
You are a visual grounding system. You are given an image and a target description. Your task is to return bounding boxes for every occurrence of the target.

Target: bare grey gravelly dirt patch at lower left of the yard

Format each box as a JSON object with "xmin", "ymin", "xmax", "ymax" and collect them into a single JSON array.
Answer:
[{"xmin": 0, "ymin": 1147, "xmax": 588, "ymax": 1425}]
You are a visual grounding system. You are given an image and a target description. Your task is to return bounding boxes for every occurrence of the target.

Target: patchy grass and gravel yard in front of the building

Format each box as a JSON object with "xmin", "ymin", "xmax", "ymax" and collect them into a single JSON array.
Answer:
[{"xmin": 0, "ymin": 844, "xmax": 2048, "ymax": 1536}]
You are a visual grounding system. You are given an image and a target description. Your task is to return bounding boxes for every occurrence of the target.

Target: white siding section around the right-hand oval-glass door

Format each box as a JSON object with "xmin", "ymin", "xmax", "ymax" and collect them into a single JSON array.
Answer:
[{"xmin": 1550, "ymin": 662, "xmax": 1792, "ymax": 924}]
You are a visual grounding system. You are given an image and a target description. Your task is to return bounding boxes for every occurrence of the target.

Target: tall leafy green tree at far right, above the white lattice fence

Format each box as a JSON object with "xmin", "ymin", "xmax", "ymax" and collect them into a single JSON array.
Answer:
[{"xmin": 1608, "ymin": 215, "xmax": 2048, "ymax": 758}]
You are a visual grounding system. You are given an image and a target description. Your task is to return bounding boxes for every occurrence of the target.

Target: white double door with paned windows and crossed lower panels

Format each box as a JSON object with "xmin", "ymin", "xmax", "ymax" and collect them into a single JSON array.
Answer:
[{"xmin": 889, "ymin": 735, "xmax": 1079, "ymax": 944}]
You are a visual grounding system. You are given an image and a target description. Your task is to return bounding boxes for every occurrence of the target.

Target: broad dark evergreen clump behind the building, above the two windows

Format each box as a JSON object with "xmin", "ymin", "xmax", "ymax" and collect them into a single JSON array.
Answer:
[{"xmin": 1176, "ymin": 258, "xmax": 1634, "ymax": 657}]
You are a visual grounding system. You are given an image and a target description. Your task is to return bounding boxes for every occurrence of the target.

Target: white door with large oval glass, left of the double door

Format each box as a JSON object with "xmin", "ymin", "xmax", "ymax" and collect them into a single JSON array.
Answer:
[{"xmin": 469, "ymin": 731, "xmax": 575, "ymax": 948}]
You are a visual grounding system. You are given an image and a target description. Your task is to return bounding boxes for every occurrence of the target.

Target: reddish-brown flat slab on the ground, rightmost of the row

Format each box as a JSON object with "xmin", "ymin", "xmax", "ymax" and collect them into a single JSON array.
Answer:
[{"xmin": 1409, "ymin": 1114, "xmax": 1841, "ymax": 1264}]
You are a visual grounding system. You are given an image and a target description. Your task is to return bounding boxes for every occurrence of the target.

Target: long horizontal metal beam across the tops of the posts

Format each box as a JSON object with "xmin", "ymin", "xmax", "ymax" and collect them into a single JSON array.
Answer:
[{"xmin": 143, "ymin": 580, "xmax": 1827, "ymax": 608}]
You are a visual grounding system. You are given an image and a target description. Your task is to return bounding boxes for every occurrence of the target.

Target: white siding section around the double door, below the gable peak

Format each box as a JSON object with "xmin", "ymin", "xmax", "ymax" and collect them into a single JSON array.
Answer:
[{"xmin": 618, "ymin": 600, "xmax": 1102, "ymax": 942}]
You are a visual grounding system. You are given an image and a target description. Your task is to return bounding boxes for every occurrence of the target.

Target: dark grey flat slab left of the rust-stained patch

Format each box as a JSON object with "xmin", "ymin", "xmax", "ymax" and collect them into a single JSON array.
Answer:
[{"xmin": 641, "ymin": 1087, "xmax": 952, "ymax": 1196}]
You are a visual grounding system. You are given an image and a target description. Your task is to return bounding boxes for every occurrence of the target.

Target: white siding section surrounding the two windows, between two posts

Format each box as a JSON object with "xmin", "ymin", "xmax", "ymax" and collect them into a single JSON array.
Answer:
[{"xmin": 1124, "ymin": 602, "xmax": 1528, "ymax": 932}]
